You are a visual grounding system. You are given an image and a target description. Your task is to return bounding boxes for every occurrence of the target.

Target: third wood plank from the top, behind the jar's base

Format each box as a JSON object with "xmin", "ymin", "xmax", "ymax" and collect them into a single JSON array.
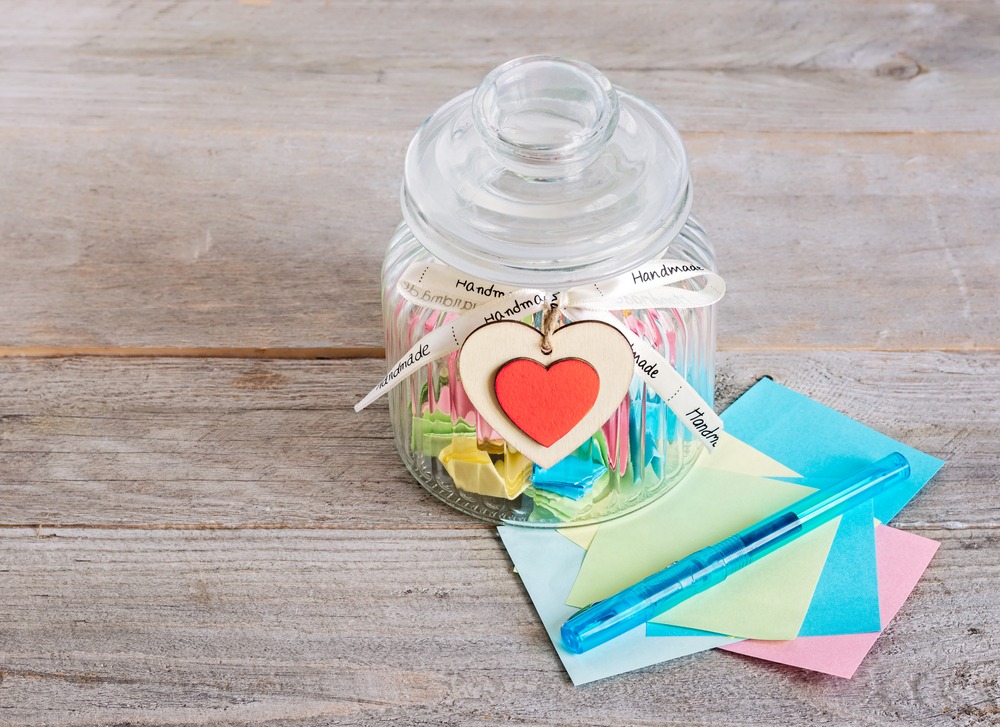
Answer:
[{"xmin": 0, "ymin": 352, "xmax": 1000, "ymax": 528}]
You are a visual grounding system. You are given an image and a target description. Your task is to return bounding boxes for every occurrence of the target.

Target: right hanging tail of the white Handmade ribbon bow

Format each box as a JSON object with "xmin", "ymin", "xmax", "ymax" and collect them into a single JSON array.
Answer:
[{"xmin": 574, "ymin": 311, "xmax": 723, "ymax": 453}]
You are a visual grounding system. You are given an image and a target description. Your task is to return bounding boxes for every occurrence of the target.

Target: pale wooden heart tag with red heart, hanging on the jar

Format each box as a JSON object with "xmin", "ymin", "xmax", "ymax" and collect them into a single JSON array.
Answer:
[{"xmin": 458, "ymin": 321, "xmax": 634, "ymax": 467}]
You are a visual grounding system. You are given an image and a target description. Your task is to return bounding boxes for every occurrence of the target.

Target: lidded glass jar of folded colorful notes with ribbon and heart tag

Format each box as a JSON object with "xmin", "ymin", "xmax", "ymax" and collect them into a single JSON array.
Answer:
[{"xmin": 356, "ymin": 56, "xmax": 725, "ymax": 526}]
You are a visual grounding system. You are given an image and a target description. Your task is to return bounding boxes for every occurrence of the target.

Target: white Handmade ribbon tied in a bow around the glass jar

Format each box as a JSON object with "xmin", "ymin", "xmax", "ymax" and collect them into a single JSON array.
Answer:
[{"xmin": 354, "ymin": 260, "xmax": 726, "ymax": 452}]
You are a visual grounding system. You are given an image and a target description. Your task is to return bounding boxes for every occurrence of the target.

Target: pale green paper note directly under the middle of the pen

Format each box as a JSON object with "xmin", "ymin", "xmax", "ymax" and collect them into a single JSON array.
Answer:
[{"xmin": 567, "ymin": 470, "xmax": 839, "ymax": 640}]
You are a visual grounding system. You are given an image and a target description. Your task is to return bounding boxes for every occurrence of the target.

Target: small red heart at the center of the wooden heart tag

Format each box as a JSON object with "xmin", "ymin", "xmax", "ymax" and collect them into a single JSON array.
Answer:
[{"xmin": 493, "ymin": 358, "xmax": 601, "ymax": 447}]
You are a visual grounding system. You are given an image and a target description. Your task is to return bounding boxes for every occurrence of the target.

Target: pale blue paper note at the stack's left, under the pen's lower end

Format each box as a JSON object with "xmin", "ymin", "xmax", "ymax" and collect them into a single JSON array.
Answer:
[{"xmin": 497, "ymin": 525, "xmax": 739, "ymax": 685}]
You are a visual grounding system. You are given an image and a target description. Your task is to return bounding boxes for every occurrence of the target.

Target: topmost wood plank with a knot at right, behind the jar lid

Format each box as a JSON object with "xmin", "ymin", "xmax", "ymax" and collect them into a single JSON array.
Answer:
[{"xmin": 0, "ymin": 0, "xmax": 1000, "ymax": 131}]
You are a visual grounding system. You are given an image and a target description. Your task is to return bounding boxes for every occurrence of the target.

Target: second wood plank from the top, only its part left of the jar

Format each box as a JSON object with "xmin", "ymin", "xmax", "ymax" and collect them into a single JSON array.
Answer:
[{"xmin": 0, "ymin": 131, "xmax": 405, "ymax": 348}]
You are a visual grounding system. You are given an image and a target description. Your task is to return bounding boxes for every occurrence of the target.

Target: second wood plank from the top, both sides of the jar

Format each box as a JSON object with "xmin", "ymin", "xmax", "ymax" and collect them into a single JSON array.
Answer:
[{"xmin": 0, "ymin": 130, "xmax": 1000, "ymax": 353}]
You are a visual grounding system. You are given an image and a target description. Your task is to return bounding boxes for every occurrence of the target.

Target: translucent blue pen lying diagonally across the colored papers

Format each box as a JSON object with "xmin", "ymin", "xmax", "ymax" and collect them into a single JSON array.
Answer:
[{"xmin": 562, "ymin": 452, "xmax": 910, "ymax": 654}]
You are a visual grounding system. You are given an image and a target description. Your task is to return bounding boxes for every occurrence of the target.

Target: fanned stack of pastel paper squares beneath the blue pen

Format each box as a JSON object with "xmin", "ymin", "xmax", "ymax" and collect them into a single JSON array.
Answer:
[{"xmin": 499, "ymin": 379, "xmax": 943, "ymax": 684}]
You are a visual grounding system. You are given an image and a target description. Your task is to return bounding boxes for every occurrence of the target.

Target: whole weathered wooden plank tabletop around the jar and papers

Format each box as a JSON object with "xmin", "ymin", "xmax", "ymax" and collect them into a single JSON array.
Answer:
[{"xmin": 0, "ymin": 0, "xmax": 1000, "ymax": 725}]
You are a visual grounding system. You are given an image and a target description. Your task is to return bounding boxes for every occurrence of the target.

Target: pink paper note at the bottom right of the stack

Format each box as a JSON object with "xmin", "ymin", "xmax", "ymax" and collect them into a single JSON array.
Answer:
[{"xmin": 719, "ymin": 525, "xmax": 940, "ymax": 679}]
